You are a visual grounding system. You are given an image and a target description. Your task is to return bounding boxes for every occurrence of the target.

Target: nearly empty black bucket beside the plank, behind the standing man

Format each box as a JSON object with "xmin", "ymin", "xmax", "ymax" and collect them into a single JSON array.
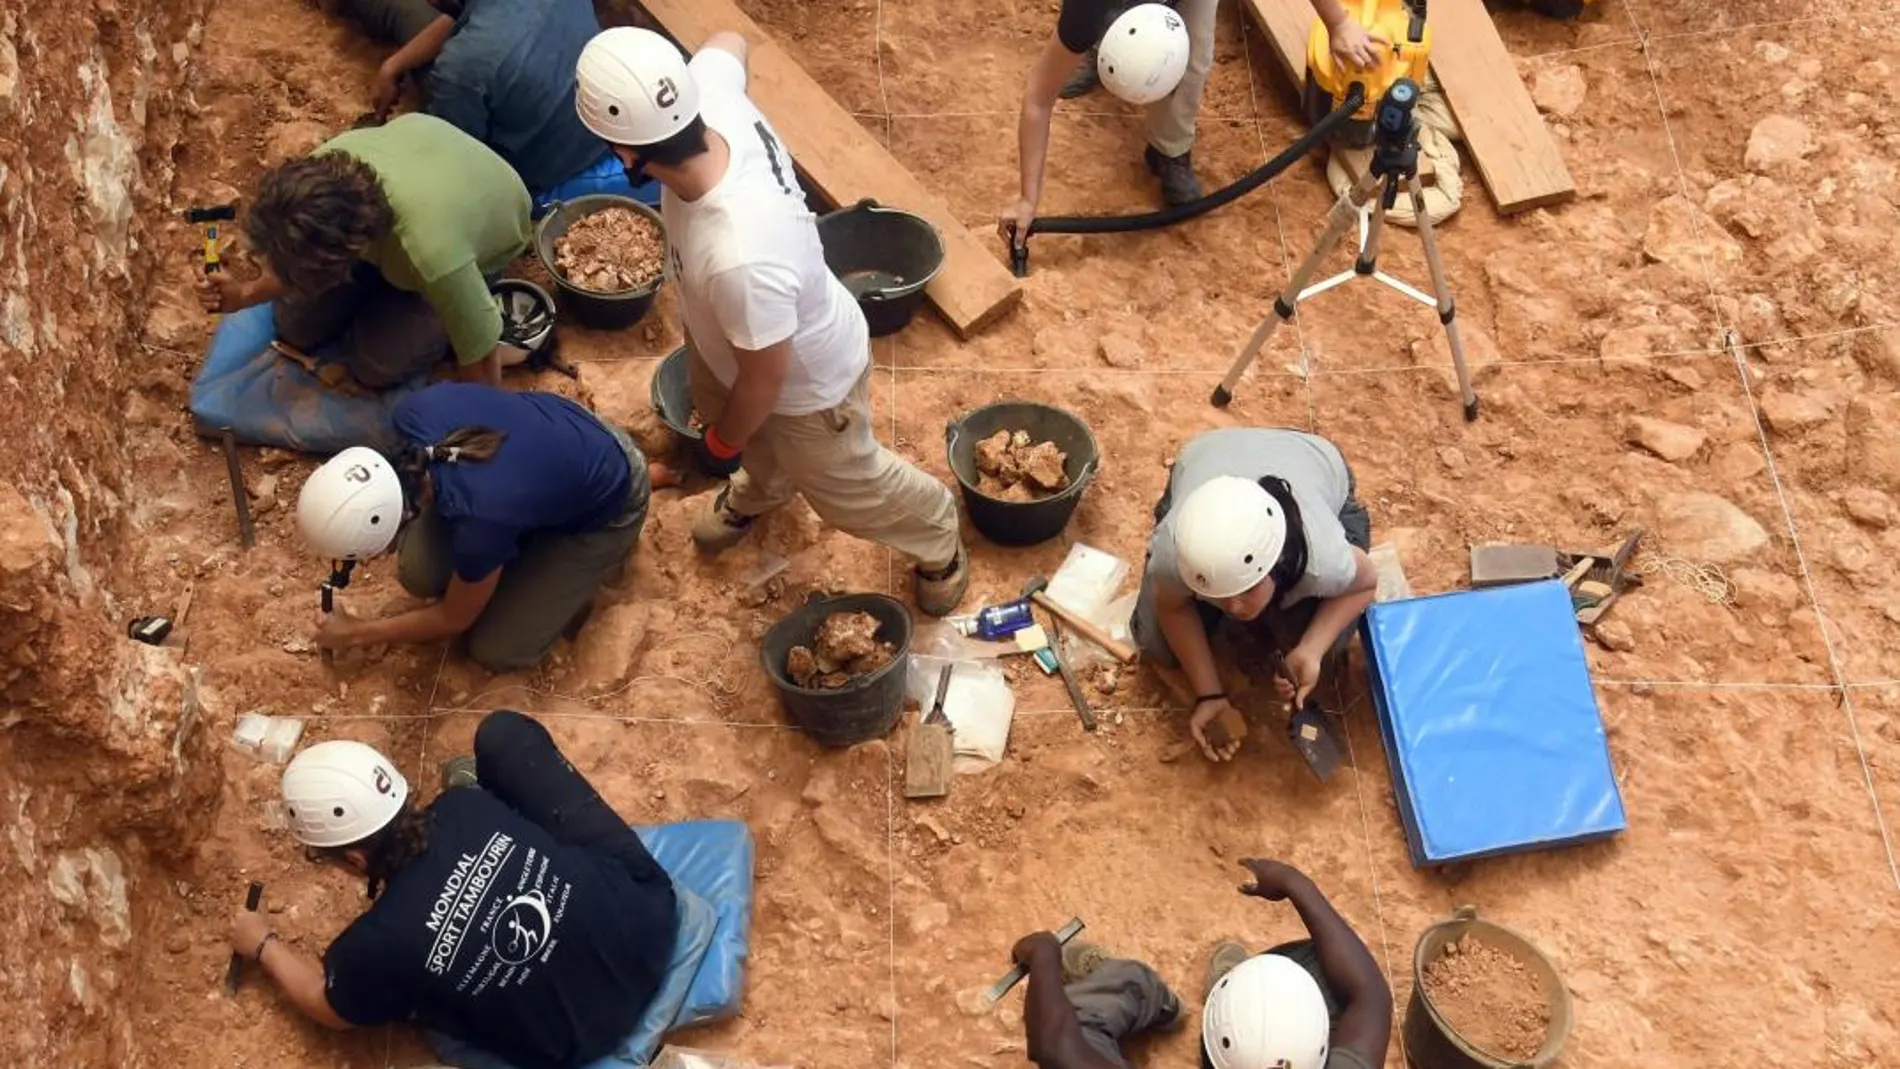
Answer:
[{"xmin": 819, "ymin": 199, "xmax": 944, "ymax": 338}]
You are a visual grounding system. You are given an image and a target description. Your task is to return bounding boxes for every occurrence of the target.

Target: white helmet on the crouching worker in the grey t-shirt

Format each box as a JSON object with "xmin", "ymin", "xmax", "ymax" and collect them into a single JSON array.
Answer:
[{"xmin": 1174, "ymin": 475, "xmax": 1286, "ymax": 600}]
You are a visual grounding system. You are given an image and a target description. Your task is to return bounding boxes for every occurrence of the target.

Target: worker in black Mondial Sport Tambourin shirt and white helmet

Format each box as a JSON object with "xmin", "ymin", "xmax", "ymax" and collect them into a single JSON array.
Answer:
[{"xmin": 232, "ymin": 710, "xmax": 714, "ymax": 1069}]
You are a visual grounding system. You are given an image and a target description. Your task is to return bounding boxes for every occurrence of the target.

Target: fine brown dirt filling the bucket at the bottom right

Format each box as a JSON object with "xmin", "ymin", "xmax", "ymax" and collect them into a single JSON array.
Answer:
[{"xmin": 1425, "ymin": 938, "xmax": 1550, "ymax": 1060}]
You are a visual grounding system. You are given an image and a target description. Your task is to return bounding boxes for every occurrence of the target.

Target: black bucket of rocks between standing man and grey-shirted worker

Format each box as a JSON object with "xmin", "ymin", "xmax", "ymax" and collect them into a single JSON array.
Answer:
[{"xmin": 944, "ymin": 401, "xmax": 1102, "ymax": 545}]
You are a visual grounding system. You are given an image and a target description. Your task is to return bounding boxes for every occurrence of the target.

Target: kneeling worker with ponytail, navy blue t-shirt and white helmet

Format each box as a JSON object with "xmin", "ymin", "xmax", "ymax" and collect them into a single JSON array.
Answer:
[{"xmin": 296, "ymin": 382, "xmax": 652, "ymax": 672}]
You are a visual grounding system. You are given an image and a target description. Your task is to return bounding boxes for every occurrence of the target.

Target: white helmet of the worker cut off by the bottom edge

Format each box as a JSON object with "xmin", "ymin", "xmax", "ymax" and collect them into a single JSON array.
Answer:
[{"xmin": 1201, "ymin": 953, "xmax": 1332, "ymax": 1069}]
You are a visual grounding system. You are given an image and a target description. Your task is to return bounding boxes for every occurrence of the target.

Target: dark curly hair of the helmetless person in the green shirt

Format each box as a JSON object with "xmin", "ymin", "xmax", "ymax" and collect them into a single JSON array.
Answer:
[{"xmin": 245, "ymin": 152, "xmax": 395, "ymax": 296}]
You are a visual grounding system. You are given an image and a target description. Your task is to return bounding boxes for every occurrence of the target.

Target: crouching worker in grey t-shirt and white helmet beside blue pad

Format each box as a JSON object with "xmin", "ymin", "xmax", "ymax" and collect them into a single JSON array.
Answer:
[{"xmin": 1132, "ymin": 427, "xmax": 1379, "ymax": 761}]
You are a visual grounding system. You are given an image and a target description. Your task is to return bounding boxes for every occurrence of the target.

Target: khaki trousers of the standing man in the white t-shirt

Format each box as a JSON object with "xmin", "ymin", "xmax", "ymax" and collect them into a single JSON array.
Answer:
[{"xmin": 688, "ymin": 346, "xmax": 961, "ymax": 568}]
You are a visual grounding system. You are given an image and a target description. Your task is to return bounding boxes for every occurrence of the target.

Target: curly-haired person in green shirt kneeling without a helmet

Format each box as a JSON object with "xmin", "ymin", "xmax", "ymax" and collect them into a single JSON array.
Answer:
[{"xmin": 200, "ymin": 114, "xmax": 532, "ymax": 389}]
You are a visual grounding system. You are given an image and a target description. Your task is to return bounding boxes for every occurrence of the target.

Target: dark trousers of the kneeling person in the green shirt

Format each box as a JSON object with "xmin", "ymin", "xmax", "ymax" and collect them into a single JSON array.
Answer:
[{"xmin": 276, "ymin": 264, "xmax": 448, "ymax": 389}]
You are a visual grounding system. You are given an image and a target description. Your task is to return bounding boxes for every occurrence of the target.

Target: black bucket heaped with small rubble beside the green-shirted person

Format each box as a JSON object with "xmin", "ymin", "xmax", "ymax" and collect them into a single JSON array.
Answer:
[{"xmin": 534, "ymin": 194, "xmax": 667, "ymax": 330}]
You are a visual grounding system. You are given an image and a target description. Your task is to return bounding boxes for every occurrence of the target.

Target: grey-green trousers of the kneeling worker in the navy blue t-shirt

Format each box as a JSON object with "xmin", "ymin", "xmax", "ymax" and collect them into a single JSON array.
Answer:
[{"xmin": 395, "ymin": 427, "xmax": 652, "ymax": 672}]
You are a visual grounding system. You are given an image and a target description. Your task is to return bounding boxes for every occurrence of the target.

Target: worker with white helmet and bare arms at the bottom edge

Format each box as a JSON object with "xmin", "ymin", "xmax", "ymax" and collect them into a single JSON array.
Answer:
[{"xmin": 1013, "ymin": 860, "xmax": 1393, "ymax": 1069}]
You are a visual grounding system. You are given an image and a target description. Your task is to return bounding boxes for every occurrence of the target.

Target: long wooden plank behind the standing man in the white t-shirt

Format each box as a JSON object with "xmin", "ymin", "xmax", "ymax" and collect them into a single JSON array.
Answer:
[{"xmin": 642, "ymin": 0, "xmax": 1022, "ymax": 338}]
